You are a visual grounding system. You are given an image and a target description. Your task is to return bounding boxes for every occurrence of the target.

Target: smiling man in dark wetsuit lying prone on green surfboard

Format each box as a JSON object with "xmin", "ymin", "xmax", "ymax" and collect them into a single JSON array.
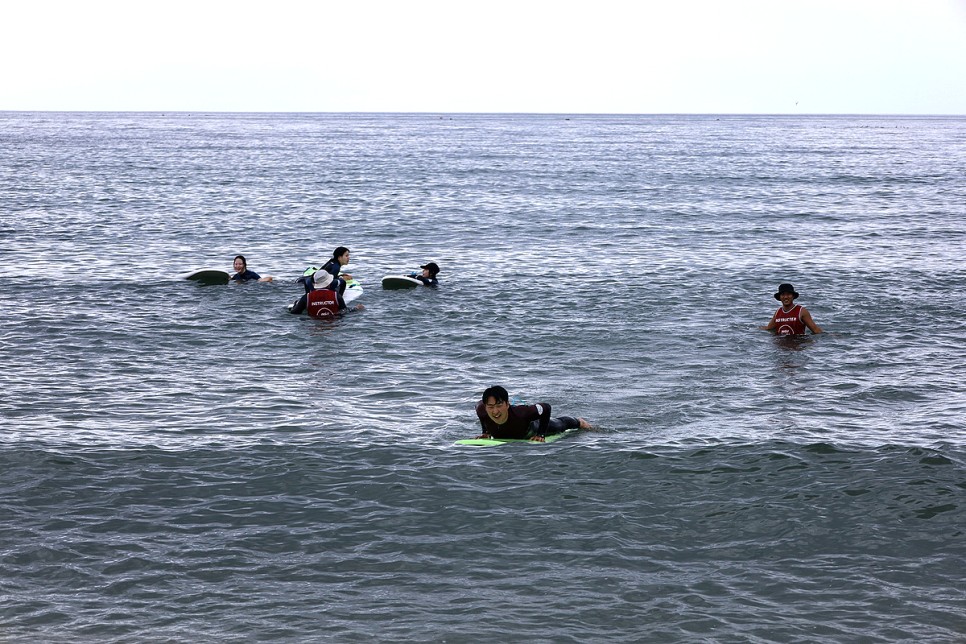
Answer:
[{"xmin": 476, "ymin": 385, "xmax": 590, "ymax": 443}]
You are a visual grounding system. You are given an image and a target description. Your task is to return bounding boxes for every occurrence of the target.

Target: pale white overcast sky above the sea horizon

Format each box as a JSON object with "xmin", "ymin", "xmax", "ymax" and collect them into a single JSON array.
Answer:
[{"xmin": 0, "ymin": 0, "xmax": 966, "ymax": 114}]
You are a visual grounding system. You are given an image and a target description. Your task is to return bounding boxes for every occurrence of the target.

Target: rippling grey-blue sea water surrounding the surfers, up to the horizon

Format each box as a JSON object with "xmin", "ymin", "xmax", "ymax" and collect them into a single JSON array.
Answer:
[{"xmin": 0, "ymin": 112, "xmax": 966, "ymax": 643}]
